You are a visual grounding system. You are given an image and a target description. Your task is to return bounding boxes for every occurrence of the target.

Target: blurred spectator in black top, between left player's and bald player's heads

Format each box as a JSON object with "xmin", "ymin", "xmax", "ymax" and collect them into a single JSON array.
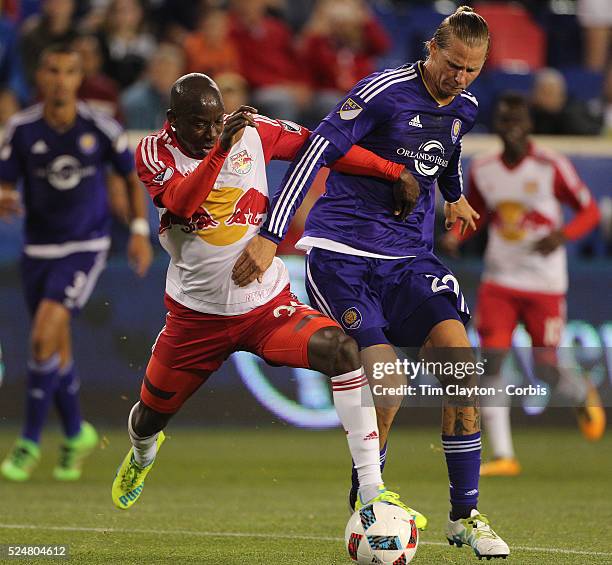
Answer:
[{"xmin": 102, "ymin": 0, "xmax": 156, "ymax": 88}]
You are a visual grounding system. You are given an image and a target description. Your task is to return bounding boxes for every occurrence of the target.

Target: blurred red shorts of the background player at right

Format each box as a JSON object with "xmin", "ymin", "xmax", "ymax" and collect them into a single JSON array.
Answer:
[{"xmin": 476, "ymin": 282, "xmax": 566, "ymax": 349}]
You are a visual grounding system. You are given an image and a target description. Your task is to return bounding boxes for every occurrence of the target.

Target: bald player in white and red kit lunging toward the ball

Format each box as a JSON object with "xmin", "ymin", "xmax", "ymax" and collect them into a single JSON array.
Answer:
[{"xmin": 112, "ymin": 73, "xmax": 426, "ymax": 511}]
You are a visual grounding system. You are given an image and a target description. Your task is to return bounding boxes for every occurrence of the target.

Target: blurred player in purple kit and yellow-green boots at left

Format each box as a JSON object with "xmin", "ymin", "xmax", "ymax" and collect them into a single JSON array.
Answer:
[{"xmin": 0, "ymin": 46, "xmax": 152, "ymax": 481}]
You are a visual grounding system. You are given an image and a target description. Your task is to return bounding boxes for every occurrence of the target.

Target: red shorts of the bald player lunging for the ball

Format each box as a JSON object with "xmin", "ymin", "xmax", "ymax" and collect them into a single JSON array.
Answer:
[{"xmin": 140, "ymin": 286, "xmax": 339, "ymax": 414}]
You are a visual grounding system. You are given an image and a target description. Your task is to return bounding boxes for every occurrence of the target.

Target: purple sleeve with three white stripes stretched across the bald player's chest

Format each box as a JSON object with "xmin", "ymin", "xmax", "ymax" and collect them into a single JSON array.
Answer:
[{"xmin": 260, "ymin": 87, "xmax": 391, "ymax": 243}]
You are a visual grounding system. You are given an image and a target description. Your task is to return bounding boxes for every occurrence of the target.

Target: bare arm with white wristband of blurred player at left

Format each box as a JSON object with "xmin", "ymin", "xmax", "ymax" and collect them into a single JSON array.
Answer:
[{"xmin": 125, "ymin": 171, "xmax": 153, "ymax": 277}]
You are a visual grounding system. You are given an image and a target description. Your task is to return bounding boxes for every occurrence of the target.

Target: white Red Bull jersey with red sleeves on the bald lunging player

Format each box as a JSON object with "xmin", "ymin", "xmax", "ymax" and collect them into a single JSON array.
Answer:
[{"xmin": 136, "ymin": 117, "xmax": 309, "ymax": 316}]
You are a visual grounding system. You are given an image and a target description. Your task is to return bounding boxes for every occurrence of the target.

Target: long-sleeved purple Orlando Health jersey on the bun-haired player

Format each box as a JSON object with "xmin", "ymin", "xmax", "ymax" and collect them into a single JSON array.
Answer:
[{"xmin": 262, "ymin": 62, "xmax": 478, "ymax": 257}]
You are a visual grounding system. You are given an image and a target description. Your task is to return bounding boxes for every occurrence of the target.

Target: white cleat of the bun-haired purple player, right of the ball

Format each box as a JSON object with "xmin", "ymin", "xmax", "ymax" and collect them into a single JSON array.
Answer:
[{"xmin": 446, "ymin": 509, "xmax": 510, "ymax": 559}]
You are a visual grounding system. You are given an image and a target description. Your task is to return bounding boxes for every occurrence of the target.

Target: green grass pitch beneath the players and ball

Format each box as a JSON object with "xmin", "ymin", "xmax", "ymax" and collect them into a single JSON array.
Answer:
[{"xmin": 0, "ymin": 427, "xmax": 612, "ymax": 565}]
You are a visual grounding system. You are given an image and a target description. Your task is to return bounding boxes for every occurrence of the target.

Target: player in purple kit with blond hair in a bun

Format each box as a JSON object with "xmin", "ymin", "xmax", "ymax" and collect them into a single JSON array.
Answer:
[{"xmin": 233, "ymin": 7, "xmax": 509, "ymax": 558}]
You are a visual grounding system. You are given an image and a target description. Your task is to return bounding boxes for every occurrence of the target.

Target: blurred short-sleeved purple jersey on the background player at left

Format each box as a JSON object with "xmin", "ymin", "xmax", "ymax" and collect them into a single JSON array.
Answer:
[{"xmin": 0, "ymin": 103, "xmax": 134, "ymax": 259}]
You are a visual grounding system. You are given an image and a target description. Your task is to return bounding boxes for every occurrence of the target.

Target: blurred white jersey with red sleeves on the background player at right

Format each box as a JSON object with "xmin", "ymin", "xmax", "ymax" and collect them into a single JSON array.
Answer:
[{"xmin": 469, "ymin": 144, "xmax": 591, "ymax": 294}]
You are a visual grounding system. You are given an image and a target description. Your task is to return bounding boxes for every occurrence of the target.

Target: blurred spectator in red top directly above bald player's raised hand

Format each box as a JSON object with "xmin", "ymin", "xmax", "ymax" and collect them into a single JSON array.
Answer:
[{"xmin": 230, "ymin": 0, "xmax": 311, "ymax": 121}]
